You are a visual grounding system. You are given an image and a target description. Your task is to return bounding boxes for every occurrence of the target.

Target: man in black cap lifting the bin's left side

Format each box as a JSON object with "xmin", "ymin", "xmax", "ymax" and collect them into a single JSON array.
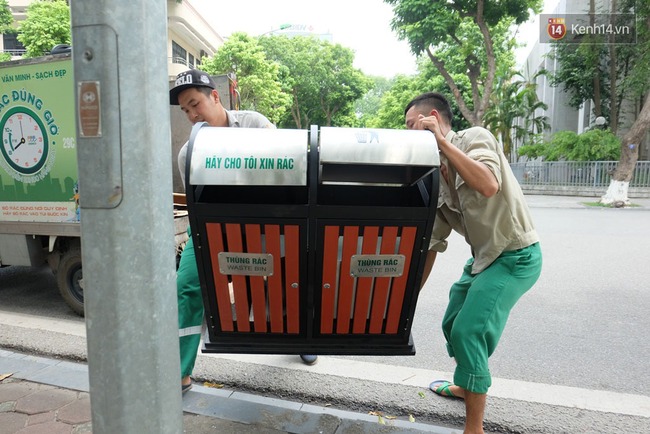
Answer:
[{"xmin": 169, "ymin": 69, "xmax": 317, "ymax": 392}]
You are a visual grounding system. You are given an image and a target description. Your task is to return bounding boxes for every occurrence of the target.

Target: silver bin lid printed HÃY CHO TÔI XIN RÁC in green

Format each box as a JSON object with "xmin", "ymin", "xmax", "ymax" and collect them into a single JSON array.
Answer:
[{"xmin": 190, "ymin": 127, "xmax": 308, "ymax": 185}]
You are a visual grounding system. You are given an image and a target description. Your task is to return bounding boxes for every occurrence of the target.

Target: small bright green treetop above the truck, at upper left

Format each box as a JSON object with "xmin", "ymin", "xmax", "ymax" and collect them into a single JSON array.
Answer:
[{"xmin": 18, "ymin": 0, "xmax": 72, "ymax": 57}]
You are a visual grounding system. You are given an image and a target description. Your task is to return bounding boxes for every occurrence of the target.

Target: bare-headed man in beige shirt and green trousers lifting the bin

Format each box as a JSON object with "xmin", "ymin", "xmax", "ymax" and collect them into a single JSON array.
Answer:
[{"xmin": 404, "ymin": 92, "xmax": 542, "ymax": 434}]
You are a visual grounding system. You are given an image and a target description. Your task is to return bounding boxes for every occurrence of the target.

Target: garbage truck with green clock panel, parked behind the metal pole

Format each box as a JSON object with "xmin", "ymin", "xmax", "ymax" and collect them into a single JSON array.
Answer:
[{"xmin": 0, "ymin": 50, "xmax": 199, "ymax": 315}]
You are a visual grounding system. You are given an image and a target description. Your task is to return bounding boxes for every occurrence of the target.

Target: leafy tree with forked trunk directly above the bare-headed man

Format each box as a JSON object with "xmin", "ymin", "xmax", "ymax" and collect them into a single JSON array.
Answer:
[{"xmin": 384, "ymin": 0, "xmax": 542, "ymax": 125}]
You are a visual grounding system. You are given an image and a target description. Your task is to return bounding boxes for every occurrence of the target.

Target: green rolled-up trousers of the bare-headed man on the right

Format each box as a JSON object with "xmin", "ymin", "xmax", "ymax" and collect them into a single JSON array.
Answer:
[{"xmin": 442, "ymin": 243, "xmax": 542, "ymax": 393}]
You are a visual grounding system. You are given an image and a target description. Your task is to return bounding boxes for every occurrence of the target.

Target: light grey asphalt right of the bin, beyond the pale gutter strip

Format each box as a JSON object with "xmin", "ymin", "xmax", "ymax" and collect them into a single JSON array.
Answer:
[{"xmin": 368, "ymin": 208, "xmax": 650, "ymax": 395}]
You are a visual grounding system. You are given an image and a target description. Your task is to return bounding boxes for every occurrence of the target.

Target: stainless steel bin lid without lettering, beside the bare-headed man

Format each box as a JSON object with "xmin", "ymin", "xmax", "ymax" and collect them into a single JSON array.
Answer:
[{"xmin": 319, "ymin": 127, "xmax": 440, "ymax": 185}]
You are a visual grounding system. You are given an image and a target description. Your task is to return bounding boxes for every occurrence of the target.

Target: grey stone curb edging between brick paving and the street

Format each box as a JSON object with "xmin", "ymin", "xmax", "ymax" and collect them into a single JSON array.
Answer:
[{"xmin": 0, "ymin": 349, "xmax": 461, "ymax": 434}]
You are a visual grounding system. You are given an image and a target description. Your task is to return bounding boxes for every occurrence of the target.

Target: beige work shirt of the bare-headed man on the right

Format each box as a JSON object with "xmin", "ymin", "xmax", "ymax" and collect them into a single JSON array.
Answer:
[{"xmin": 429, "ymin": 127, "xmax": 539, "ymax": 274}]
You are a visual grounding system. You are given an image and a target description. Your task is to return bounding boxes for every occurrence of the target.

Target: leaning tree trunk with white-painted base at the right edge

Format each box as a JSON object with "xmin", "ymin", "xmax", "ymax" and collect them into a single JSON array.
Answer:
[{"xmin": 600, "ymin": 92, "xmax": 650, "ymax": 205}]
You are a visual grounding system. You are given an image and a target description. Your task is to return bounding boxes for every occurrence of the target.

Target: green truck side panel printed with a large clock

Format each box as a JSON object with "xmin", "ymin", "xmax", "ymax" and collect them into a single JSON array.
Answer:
[{"xmin": 0, "ymin": 55, "xmax": 79, "ymax": 227}]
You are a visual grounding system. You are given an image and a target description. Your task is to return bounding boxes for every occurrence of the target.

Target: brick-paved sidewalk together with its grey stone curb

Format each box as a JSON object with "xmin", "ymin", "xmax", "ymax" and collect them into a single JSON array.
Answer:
[{"xmin": 0, "ymin": 349, "xmax": 462, "ymax": 434}]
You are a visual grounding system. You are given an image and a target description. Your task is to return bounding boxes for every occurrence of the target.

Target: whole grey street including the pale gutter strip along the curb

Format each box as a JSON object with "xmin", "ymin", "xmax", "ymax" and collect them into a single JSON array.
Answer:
[{"xmin": 0, "ymin": 197, "xmax": 650, "ymax": 433}]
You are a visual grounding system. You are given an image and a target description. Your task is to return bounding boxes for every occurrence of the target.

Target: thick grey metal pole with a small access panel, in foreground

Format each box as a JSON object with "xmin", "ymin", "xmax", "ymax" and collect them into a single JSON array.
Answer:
[{"xmin": 70, "ymin": 0, "xmax": 183, "ymax": 434}]
